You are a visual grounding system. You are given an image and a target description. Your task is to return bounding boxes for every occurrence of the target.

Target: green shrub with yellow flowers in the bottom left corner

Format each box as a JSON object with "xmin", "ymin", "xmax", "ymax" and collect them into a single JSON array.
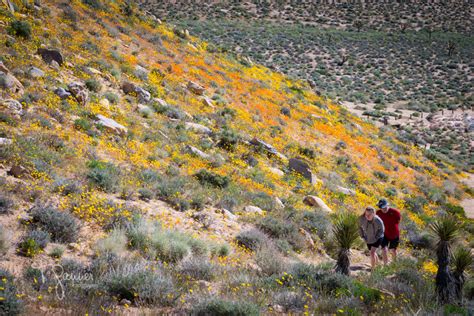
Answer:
[{"xmin": 0, "ymin": 269, "xmax": 23, "ymax": 316}]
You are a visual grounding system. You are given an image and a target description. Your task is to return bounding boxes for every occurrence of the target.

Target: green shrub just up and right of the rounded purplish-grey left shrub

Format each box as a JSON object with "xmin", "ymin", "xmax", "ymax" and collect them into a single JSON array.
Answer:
[{"xmin": 87, "ymin": 160, "xmax": 120, "ymax": 193}]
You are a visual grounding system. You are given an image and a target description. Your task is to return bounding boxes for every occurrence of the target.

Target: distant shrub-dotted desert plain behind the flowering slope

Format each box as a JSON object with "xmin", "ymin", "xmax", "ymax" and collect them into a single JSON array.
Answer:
[{"xmin": 141, "ymin": 1, "xmax": 474, "ymax": 170}]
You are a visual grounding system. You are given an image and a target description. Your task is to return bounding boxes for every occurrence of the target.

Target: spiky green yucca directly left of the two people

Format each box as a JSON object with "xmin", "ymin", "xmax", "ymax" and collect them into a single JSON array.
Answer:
[{"xmin": 333, "ymin": 213, "xmax": 359, "ymax": 275}]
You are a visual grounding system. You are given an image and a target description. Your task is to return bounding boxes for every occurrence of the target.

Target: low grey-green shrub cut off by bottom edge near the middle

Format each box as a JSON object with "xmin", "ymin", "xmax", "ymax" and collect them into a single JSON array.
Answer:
[{"xmin": 191, "ymin": 298, "xmax": 260, "ymax": 316}]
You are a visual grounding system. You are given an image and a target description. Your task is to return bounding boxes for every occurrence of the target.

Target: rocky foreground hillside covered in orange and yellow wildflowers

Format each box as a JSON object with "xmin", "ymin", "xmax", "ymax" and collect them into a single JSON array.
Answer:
[{"xmin": 0, "ymin": 0, "xmax": 474, "ymax": 315}]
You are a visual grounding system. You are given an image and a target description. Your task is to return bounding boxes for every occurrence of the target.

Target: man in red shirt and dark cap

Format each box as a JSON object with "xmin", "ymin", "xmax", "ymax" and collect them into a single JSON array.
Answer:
[{"xmin": 377, "ymin": 199, "xmax": 401, "ymax": 264}]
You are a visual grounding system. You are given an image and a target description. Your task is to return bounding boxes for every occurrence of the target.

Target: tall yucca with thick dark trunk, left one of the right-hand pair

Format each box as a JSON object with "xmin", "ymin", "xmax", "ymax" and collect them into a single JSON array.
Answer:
[{"xmin": 430, "ymin": 216, "xmax": 458, "ymax": 304}]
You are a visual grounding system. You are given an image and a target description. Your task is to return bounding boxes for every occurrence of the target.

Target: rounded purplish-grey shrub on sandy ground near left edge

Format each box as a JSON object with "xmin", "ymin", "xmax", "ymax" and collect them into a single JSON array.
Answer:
[{"xmin": 32, "ymin": 206, "xmax": 79, "ymax": 243}]
